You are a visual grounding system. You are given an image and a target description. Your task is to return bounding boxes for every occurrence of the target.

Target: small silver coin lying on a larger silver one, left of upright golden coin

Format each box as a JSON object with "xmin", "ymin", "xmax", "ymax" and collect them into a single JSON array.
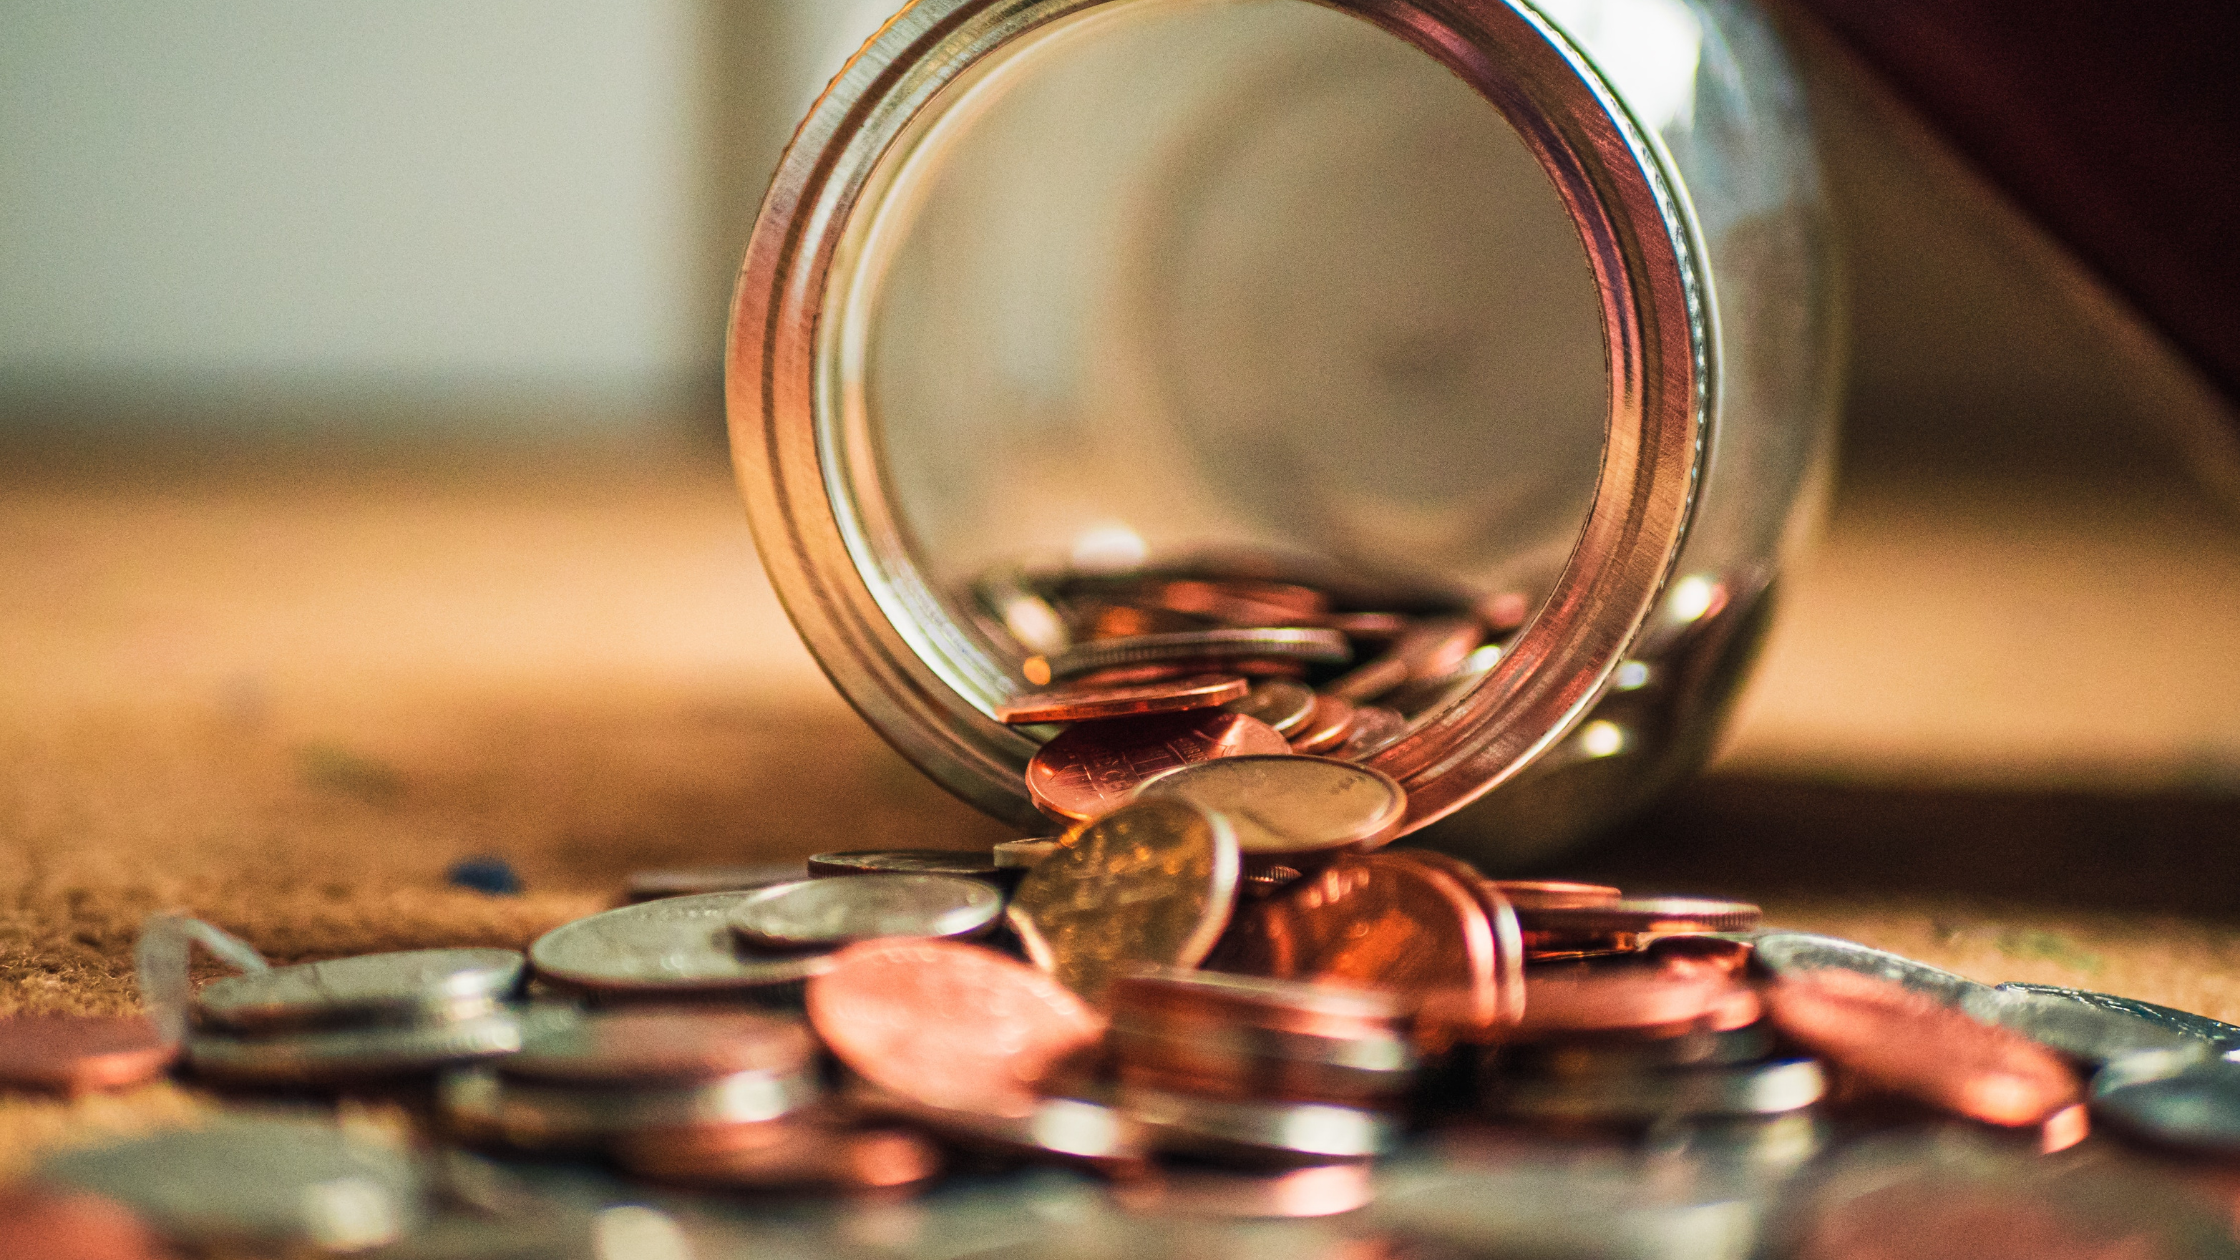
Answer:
[{"xmin": 730, "ymin": 874, "xmax": 1004, "ymax": 948}]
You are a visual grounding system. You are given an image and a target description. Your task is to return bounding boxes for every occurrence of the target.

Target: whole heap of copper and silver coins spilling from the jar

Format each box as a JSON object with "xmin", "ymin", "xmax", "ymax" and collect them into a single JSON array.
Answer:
[{"xmin": 13, "ymin": 581, "xmax": 2240, "ymax": 1258}]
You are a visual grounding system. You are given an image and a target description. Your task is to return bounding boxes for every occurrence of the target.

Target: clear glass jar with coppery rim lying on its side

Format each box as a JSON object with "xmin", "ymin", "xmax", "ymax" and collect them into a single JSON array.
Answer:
[{"xmin": 728, "ymin": 0, "xmax": 1837, "ymax": 870}]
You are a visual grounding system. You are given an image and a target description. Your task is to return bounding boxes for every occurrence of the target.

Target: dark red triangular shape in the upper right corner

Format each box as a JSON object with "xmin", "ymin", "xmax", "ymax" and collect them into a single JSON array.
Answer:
[{"xmin": 1799, "ymin": 0, "xmax": 2240, "ymax": 408}]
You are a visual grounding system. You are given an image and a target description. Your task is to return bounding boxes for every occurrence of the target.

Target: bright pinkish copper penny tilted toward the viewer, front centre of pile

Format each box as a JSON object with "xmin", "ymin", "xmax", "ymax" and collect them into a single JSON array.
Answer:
[{"xmin": 809, "ymin": 939, "xmax": 1104, "ymax": 1117}]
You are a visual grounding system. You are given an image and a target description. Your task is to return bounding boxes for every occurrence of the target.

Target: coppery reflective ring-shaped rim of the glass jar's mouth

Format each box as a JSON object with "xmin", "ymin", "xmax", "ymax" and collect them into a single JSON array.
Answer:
[{"xmin": 728, "ymin": 0, "xmax": 1714, "ymax": 830}]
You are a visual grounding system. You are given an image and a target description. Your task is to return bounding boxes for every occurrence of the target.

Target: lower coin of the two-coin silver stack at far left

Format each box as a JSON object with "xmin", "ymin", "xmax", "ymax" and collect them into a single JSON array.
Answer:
[{"xmin": 186, "ymin": 1011, "xmax": 546, "ymax": 1085}]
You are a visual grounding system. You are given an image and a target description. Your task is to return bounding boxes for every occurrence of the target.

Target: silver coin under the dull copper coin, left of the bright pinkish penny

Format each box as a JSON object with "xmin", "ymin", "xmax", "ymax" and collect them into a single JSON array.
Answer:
[{"xmin": 439, "ymin": 1065, "xmax": 822, "ymax": 1150}]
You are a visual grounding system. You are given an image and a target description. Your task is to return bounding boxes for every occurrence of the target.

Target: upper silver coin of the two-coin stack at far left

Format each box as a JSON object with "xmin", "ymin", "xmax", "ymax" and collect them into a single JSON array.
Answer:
[{"xmin": 195, "ymin": 948, "xmax": 524, "ymax": 1031}]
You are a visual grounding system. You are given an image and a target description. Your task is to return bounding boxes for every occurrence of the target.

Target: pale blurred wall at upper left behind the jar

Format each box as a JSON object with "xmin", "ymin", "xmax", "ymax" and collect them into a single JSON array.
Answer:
[{"xmin": 0, "ymin": 0, "xmax": 892, "ymax": 424}]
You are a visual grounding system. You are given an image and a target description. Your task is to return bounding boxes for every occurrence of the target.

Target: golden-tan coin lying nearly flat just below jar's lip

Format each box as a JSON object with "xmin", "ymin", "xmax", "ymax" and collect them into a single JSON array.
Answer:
[{"xmin": 1136, "ymin": 756, "xmax": 1407, "ymax": 859}]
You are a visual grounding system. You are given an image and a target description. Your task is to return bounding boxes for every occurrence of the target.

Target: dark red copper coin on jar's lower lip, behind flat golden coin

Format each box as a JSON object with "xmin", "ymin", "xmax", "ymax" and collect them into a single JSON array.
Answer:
[{"xmin": 1026, "ymin": 708, "xmax": 1290, "ymax": 823}]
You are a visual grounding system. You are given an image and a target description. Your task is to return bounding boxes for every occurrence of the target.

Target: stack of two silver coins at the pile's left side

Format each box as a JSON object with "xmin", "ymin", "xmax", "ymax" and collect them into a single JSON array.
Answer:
[{"xmin": 186, "ymin": 948, "xmax": 524, "ymax": 1085}]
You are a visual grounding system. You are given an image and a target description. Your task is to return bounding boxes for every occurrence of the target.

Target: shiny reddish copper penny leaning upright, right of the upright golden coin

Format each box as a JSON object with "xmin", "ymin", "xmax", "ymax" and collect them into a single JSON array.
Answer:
[{"xmin": 1207, "ymin": 852, "xmax": 1503, "ymax": 1025}]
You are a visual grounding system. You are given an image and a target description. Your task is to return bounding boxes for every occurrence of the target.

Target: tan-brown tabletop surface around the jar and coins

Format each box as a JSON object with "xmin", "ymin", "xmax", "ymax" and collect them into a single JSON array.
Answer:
[{"xmin": 0, "ymin": 434, "xmax": 2240, "ymax": 1164}]
